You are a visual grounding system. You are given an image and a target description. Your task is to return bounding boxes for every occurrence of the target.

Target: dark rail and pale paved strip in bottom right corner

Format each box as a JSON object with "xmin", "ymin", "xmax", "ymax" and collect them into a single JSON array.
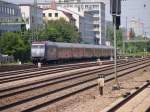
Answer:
[{"xmin": 102, "ymin": 80, "xmax": 150, "ymax": 112}]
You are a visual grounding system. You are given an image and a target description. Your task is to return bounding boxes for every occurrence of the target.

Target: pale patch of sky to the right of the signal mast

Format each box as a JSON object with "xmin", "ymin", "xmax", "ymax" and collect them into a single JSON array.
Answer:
[{"xmin": 121, "ymin": 0, "xmax": 150, "ymax": 36}]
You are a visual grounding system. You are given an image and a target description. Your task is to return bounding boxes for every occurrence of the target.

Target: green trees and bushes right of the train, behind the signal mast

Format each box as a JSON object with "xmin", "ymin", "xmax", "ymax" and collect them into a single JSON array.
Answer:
[{"xmin": 106, "ymin": 27, "xmax": 150, "ymax": 55}]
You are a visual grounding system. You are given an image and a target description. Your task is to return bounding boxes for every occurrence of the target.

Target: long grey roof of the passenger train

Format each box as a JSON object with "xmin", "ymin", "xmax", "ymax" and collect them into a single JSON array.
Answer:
[{"xmin": 33, "ymin": 41, "xmax": 113, "ymax": 49}]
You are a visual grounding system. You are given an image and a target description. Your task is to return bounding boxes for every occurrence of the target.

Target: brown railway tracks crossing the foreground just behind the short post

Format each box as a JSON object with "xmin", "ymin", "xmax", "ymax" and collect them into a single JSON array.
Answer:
[{"xmin": 0, "ymin": 59, "xmax": 150, "ymax": 112}]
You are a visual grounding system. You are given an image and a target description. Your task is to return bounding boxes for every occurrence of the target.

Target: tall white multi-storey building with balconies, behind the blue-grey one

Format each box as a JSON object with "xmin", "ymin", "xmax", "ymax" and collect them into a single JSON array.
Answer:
[{"xmin": 38, "ymin": 0, "xmax": 106, "ymax": 44}]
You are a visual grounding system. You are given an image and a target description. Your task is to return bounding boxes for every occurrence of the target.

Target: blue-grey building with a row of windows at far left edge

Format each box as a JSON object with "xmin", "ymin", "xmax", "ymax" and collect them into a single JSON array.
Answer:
[{"xmin": 0, "ymin": 1, "xmax": 22, "ymax": 33}]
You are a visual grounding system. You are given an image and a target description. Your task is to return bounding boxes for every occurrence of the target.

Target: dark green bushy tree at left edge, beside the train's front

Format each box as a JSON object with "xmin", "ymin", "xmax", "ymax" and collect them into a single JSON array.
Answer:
[{"xmin": 0, "ymin": 32, "xmax": 29, "ymax": 61}]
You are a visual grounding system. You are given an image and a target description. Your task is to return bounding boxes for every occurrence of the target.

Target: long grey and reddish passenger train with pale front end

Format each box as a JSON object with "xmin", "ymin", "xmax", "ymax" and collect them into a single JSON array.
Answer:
[{"xmin": 31, "ymin": 41, "xmax": 114, "ymax": 63}]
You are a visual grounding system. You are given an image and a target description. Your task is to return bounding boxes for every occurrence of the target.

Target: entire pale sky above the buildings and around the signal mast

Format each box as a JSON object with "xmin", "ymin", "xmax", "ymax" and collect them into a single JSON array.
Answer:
[{"xmin": 4, "ymin": 0, "xmax": 150, "ymax": 35}]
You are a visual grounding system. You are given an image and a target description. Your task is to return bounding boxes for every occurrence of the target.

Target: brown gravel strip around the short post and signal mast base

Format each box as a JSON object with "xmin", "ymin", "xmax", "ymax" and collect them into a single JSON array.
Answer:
[{"xmin": 37, "ymin": 67, "xmax": 150, "ymax": 112}]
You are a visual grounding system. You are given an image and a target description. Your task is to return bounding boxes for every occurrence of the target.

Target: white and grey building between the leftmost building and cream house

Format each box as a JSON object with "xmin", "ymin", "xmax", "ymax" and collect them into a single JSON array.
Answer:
[{"xmin": 19, "ymin": 4, "xmax": 43, "ymax": 30}]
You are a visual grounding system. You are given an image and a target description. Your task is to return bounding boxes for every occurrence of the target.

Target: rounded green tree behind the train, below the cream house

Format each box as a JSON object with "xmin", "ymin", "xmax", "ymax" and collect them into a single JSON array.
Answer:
[{"xmin": 39, "ymin": 18, "xmax": 79, "ymax": 43}]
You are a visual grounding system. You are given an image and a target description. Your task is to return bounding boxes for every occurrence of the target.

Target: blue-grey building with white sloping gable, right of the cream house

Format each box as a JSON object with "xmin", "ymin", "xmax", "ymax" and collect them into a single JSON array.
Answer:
[{"xmin": 54, "ymin": 7, "xmax": 95, "ymax": 44}]
